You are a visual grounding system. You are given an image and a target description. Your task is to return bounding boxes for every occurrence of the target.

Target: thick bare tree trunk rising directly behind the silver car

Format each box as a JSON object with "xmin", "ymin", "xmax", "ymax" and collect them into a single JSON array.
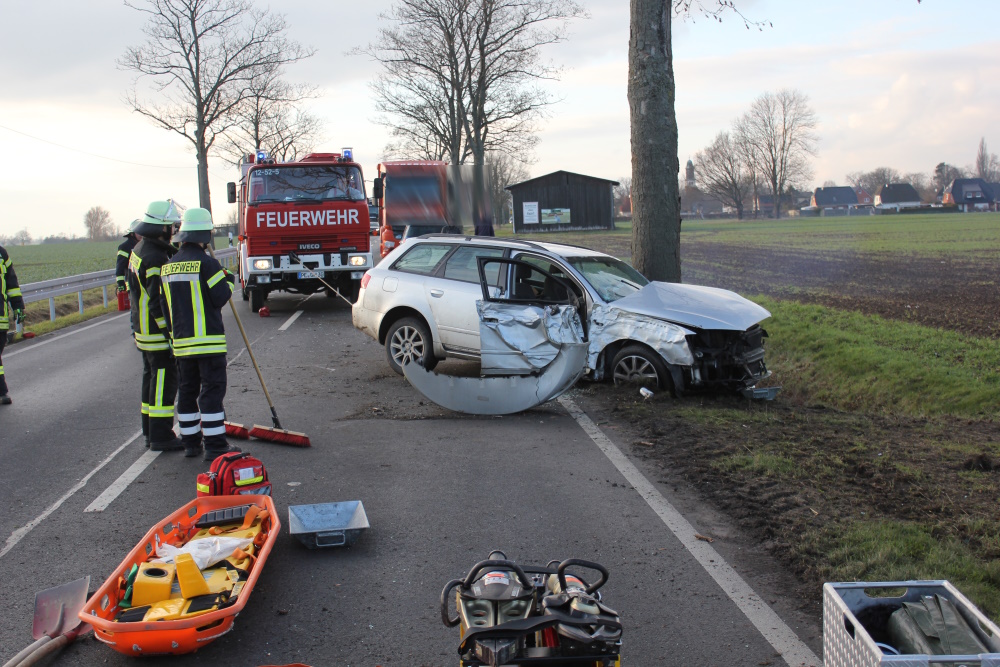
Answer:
[{"xmin": 628, "ymin": 0, "xmax": 681, "ymax": 282}]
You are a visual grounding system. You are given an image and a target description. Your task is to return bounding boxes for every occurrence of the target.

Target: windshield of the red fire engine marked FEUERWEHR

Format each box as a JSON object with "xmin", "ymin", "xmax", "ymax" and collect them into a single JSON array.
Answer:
[{"xmin": 249, "ymin": 164, "xmax": 365, "ymax": 204}]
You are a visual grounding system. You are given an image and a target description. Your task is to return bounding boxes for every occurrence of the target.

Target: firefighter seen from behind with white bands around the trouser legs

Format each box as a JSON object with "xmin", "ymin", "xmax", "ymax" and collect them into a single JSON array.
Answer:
[{"xmin": 160, "ymin": 208, "xmax": 240, "ymax": 461}]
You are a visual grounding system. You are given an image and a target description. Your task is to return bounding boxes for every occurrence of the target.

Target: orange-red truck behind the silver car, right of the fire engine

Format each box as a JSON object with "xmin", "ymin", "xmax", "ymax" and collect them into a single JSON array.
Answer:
[{"xmin": 373, "ymin": 160, "xmax": 461, "ymax": 257}]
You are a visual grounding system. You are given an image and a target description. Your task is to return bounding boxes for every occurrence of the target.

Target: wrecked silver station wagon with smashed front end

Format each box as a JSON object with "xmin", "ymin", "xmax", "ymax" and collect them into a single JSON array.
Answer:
[{"xmin": 352, "ymin": 234, "xmax": 770, "ymax": 394}]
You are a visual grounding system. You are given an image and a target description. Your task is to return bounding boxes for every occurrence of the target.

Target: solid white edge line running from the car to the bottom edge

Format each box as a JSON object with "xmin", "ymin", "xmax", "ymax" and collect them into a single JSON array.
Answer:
[{"xmin": 558, "ymin": 396, "xmax": 823, "ymax": 667}]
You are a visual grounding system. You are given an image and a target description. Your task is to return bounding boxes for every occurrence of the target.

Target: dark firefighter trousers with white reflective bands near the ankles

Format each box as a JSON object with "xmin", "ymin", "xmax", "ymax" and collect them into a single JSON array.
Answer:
[{"xmin": 177, "ymin": 354, "xmax": 229, "ymax": 451}]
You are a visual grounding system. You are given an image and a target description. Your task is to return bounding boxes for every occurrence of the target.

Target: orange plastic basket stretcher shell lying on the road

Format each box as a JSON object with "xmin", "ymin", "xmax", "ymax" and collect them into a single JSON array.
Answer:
[{"xmin": 80, "ymin": 495, "xmax": 281, "ymax": 656}]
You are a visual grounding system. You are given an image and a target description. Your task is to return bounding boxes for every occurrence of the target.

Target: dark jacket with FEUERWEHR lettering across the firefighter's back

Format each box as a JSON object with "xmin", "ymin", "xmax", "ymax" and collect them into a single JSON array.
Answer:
[{"xmin": 160, "ymin": 243, "xmax": 236, "ymax": 357}]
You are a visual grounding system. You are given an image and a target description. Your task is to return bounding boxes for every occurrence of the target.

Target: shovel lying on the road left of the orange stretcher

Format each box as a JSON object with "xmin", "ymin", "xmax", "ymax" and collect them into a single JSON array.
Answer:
[{"xmin": 3, "ymin": 576, "xmax": 90, "ymax": 667}]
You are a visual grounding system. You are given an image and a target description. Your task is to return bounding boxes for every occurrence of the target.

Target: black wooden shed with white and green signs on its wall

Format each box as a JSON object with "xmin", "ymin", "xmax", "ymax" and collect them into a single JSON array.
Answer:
[{"xmin": 505, "ymin": 171, "xmax": 618, "ymax": 234}]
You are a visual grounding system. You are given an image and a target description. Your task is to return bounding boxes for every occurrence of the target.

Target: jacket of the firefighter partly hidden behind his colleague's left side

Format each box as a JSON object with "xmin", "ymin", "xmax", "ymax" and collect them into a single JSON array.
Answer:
[{"xmin": 128, "ymin": 237, "xmax": 177, "ymax": 352}]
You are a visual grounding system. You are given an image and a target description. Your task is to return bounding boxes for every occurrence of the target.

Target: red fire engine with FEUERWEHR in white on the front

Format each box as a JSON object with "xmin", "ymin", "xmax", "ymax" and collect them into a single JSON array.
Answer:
[{"xmin": 228, "ymin": 148, "xmax": 374, "ymax": 312}]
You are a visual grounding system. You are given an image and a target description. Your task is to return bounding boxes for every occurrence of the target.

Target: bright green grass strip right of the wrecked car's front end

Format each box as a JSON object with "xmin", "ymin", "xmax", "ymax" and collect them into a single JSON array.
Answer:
[{"xmin": 754, "ymin": 297, "xmax": 1000, "ymax": 417}]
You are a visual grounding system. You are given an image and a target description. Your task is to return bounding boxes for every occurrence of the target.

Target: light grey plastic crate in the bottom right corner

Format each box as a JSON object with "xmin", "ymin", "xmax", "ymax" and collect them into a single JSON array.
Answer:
[{"xmin": 823, "ymin": 581, "xmax": 1000, "ymax": 667}]
